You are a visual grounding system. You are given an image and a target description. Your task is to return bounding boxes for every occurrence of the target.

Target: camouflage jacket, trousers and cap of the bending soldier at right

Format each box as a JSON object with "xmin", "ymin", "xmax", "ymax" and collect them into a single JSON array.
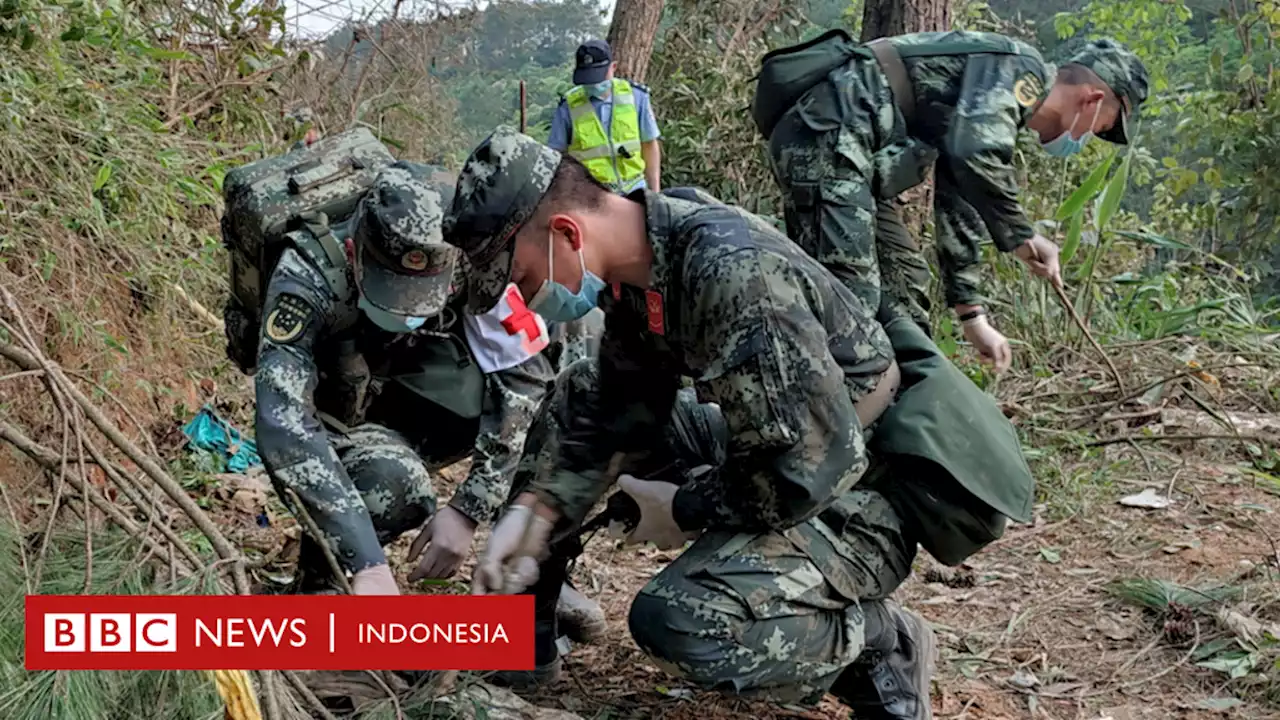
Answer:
[{"xmin": 767, "ymin": 31, "xmax": 1147, "ymax": 332}]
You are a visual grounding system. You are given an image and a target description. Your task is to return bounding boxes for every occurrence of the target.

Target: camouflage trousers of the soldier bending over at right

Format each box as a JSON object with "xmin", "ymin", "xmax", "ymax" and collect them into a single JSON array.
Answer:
[{"xmin": 769, "ymin": 63, "xmax": 931, "ymax": 332}]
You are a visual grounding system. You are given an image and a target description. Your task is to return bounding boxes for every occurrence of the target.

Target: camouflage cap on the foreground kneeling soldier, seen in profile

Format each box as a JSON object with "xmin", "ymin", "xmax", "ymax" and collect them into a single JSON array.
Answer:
[{"xmin": 444, "ymin": 126, "xmax": 561, "ymax": 313}]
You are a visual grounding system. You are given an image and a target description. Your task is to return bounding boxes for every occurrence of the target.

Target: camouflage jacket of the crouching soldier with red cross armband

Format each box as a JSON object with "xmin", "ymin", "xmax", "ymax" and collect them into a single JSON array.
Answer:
[{"xmin": 255, "ymin": 243, "xmax": 553, "ymax": 571}]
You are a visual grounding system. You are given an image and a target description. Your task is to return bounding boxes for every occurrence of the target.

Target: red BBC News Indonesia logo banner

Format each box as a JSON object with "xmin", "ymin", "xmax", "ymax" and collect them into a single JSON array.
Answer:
[{"xmin": 24, "ymin": 596, "xmax": 534, "ymax": 671}]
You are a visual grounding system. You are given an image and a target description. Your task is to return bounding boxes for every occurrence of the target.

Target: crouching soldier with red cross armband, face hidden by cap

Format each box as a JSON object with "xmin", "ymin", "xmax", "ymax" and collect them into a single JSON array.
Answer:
[{"xmin": 256, "ymin": 161, "xmax": 603, "ymax": 639}]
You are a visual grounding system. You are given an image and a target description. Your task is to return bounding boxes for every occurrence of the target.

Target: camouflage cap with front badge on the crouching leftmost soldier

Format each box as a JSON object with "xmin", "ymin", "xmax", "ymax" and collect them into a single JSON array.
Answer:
[{"xmin": 353, "ymin": 160, "xmax": 458, "ymax": 318}]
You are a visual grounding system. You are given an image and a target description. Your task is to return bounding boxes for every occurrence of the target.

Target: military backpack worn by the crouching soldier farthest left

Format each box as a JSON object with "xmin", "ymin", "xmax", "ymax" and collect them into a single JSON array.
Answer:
[{"xmin": 221, "ymin": 127, "xmax": 396, "ymax": 374}]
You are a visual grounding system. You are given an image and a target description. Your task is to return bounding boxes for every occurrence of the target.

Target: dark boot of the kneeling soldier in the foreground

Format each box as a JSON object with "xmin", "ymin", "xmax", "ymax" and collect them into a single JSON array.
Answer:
[{"xmin": 831, "ymin": 600, "xmax": 937, "ymax": 720}]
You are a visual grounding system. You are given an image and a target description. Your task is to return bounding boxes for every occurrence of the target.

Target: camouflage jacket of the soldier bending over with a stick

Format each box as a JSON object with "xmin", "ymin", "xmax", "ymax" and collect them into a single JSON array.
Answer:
[{"xmin": 880, "ymin": 31, "xmax": 1055, "ymax": 305}]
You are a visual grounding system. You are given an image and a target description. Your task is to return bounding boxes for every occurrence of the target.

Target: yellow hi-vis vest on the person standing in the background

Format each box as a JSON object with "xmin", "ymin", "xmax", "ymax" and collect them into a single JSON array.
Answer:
[{"xmin": 564, "ymin": 78, "xmax": 644, "ymax": 193}]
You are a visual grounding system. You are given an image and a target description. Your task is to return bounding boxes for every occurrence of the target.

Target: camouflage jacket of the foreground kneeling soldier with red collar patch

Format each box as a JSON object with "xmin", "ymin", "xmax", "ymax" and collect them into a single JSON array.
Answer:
[{"xmin": 532, "ymin": 188, "xmax": 892, "ymax": 530}]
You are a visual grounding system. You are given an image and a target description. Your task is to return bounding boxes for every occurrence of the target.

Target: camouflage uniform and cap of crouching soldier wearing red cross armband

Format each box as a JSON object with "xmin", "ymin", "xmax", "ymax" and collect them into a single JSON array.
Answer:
[{"xmin": 256, "ymin": 163, "xmax": 552, "ymax": 579}]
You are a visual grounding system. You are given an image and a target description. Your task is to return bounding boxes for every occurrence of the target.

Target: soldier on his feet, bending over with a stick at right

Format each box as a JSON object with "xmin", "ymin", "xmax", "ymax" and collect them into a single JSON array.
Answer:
[{"xmin": 754, "ymin": 31, "xmax": 1148, "ymax": 372}]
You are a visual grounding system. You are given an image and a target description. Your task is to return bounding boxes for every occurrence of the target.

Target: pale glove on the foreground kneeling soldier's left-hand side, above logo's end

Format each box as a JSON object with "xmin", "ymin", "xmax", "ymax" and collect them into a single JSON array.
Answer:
[{"xmin": 471, "ymin": 505, "xmax": 554, "ymax": 594}]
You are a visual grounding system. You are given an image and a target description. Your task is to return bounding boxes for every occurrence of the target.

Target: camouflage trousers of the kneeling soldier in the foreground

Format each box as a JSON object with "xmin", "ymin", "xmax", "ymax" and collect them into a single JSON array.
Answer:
[{"xmin": 628, "ymin": 476, "xmax": 915, "ymax": 705}]
